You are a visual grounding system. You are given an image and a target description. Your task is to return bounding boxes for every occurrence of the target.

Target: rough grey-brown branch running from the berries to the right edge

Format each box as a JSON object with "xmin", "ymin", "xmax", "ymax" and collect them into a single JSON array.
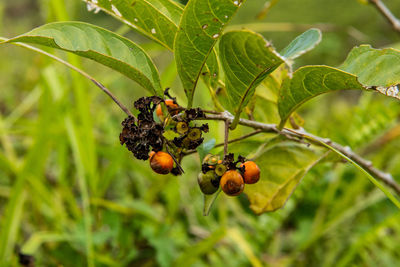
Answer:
[{"xmin": 196, "ymin": 113, "xmax": 400, "ymax": 195}]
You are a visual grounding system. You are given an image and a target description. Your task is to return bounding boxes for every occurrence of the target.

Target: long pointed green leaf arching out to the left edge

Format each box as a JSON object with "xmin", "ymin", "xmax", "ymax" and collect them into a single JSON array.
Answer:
[{"xmin": 6, "ymin": 22, "xmax": 163, "ymax": 96}]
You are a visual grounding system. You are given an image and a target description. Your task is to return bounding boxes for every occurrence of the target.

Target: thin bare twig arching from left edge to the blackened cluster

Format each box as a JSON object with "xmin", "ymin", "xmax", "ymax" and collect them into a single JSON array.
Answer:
[{"xmin": 0, "ymin": 37, "xmax": 137, "ymax": 121}]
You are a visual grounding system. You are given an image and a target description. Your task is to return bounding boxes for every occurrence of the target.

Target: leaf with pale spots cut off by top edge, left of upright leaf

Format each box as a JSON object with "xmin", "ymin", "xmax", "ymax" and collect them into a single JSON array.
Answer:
[{"xmin": 84, "ymin": 0, "xmax": 183, "ymax": 50}]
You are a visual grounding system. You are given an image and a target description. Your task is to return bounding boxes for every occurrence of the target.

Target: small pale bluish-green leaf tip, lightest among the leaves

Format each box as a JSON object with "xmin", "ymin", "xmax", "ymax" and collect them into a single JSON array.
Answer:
[{"xmin": 280, "ymin": 28, "xmax": 322, "ymax": 60}]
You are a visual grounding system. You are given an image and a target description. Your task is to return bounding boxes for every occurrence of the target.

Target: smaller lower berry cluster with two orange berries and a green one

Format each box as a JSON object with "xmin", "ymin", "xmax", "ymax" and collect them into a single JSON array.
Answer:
[{"xmin": 197, "ymin": 154, "xmax": 260, "ymax": 196}]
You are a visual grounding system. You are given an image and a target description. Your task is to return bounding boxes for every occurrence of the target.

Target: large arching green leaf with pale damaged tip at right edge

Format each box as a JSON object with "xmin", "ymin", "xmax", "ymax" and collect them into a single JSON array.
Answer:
[{"xmin": 278, "ymin": 45, "xmax": 400, "ymax": 127}]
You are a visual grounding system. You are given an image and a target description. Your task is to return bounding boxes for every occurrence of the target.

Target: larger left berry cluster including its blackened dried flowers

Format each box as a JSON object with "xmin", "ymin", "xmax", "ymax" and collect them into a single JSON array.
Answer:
[{"xmin": 119, "ymin": 93, "xmax": 208, "ymax": 175}]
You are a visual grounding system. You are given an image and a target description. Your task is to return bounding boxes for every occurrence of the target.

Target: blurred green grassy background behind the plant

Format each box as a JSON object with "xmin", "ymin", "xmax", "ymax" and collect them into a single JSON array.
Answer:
[{"xmin": 0, "ymin": 0, "xmax": 400, "ymax": 266}]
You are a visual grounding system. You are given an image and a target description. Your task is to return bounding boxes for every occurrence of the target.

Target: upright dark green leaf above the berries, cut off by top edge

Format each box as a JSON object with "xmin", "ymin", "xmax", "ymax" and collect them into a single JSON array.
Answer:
[{"xmin": 174, "ymin": 0, "xmax": 244, "ymax": 107}]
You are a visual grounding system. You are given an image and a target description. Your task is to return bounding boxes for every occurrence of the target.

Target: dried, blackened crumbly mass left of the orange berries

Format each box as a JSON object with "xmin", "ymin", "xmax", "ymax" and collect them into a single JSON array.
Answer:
[{"xmin": 119, "ymin": 96, "xmax": 164, "ymax": 160}]
